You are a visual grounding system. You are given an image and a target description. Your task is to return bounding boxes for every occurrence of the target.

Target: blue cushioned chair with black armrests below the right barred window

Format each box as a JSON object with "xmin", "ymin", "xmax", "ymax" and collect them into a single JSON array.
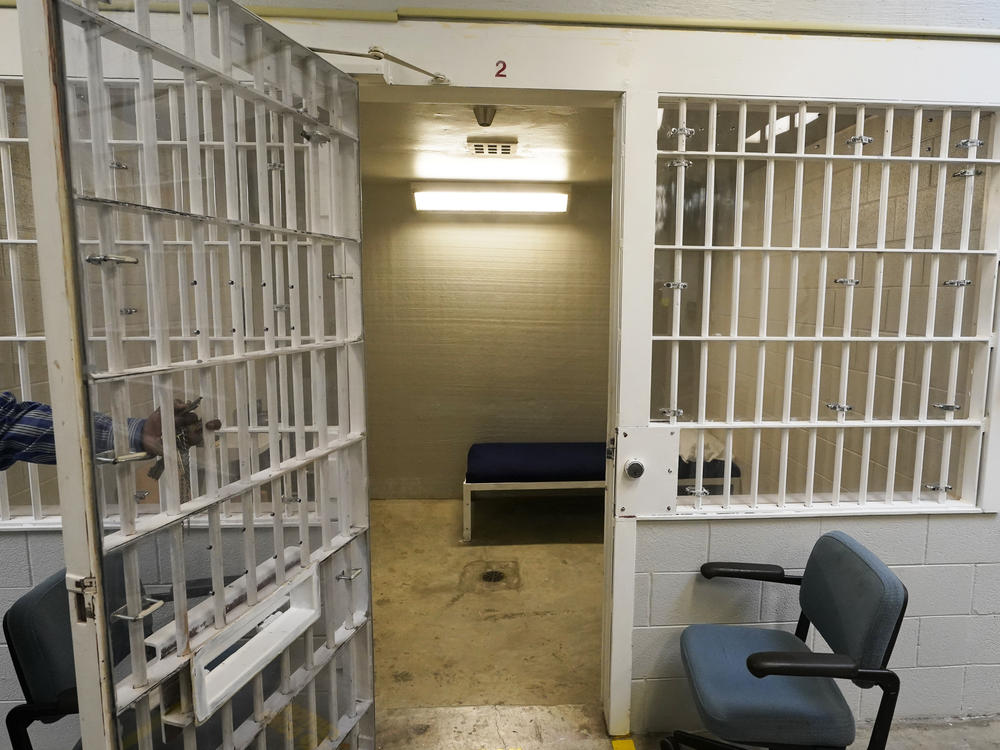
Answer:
[{"xmin": 661, "ymin": 531, "xmax": 907, "ymax": 750}]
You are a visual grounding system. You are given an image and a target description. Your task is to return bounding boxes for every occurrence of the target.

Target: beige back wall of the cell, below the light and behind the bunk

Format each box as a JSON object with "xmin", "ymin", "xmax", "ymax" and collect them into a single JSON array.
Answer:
[{"xmin": 363, "ymin": 181, "xmax": 611, "ymax": 498}]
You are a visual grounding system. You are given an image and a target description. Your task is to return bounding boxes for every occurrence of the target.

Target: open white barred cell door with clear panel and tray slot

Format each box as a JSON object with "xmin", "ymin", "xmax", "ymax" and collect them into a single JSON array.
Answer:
[{"xmin": 18, "ymin": 0, "xmax": 374, "ymax": 750}]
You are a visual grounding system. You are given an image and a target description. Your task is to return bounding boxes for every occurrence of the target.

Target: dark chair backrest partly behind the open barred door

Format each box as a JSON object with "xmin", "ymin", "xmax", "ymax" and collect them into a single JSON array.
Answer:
[{"xmin": 3, "ymin": 555, "xmax": 129, "ymax": 704}]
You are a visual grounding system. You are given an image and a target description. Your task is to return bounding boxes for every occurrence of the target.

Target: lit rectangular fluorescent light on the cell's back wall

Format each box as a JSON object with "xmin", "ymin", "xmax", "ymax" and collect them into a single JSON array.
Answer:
[{"xmin": 413, "ymin": 183, "xmax": 569, "ymax": 214}]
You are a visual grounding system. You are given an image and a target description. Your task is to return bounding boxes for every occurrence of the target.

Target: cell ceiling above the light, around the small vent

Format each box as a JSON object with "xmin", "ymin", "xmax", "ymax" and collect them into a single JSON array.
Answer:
[{"xmin": 361, "ymin": 101, "xmax": 612, "ymax": 183}]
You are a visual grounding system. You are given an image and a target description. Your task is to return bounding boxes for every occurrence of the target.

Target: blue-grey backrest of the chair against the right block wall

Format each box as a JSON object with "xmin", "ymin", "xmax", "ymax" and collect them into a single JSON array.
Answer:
[{"xmin": 799, "ymin": 531, "xmax": 906, "ymax": 669}]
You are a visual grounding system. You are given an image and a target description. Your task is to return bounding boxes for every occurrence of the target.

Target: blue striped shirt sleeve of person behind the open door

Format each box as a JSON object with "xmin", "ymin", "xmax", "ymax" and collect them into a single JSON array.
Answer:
[{"xmin": 0, "ymin": 391, "xmax": 146, "ymax": 471}]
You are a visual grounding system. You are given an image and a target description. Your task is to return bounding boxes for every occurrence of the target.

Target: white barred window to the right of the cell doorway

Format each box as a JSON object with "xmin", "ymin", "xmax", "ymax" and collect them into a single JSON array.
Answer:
[{"xmin": 650, "ymin": 99, "xmax": 1000, "ymax": 512}]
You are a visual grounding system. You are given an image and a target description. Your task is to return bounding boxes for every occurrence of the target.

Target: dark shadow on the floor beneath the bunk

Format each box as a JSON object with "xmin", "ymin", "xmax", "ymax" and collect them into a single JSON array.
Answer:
[{"xmin": 472, "ymin": 490, "xmax": 604, "ymax": 546}]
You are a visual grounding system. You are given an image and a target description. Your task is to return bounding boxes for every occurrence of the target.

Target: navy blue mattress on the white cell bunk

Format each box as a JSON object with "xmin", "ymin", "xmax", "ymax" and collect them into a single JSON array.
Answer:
[{"xmin": 465, "ymin": 443, "xmax": 606, "ymax": 483}]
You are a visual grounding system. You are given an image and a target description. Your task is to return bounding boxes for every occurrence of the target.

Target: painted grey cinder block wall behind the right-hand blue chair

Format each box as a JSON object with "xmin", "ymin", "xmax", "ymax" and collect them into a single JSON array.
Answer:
[{"xmin": 631, "ymin": 515, "xmax": 1000, "ymax": 733}]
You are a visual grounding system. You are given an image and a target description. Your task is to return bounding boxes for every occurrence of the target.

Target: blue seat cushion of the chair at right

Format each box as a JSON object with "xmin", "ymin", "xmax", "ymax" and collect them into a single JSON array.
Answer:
[{"xmin": 681, "ymin": 625, "xmax": 854, "ymax": 747}]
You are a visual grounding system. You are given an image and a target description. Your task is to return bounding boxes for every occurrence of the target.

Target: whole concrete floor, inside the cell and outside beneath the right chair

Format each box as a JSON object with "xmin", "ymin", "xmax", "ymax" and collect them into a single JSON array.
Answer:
[{"xmin": 371, "ymin": 500, "xmax": 1000, "ymax": 750}]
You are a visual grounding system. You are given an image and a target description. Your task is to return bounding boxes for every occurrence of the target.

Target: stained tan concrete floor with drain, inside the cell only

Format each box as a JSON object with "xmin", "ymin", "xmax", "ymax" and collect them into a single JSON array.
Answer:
[{"xmin": 371, "ymin": 500, "xmax": 603, "ymax": 712}]
